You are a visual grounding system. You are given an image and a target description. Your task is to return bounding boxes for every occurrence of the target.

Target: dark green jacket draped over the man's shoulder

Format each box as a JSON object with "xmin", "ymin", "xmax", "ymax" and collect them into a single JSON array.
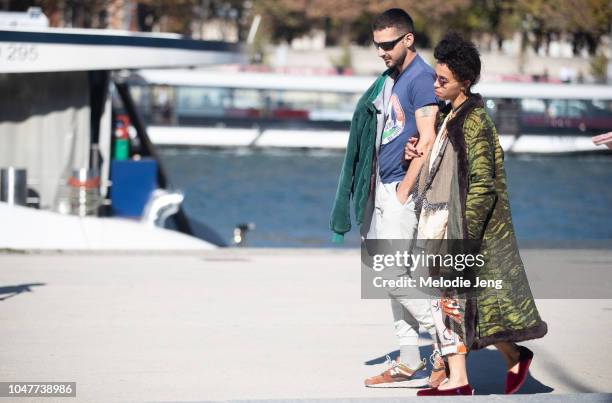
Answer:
[{"xmin": 329, "ymin": 70, "xmax": 390, "ymax": 242}]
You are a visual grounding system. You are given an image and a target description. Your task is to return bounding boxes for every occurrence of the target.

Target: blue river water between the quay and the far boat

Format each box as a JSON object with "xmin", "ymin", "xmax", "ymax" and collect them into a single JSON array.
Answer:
[{"xmin": 160, "ymin": 148, "xmax": 612, "ymax": 247}]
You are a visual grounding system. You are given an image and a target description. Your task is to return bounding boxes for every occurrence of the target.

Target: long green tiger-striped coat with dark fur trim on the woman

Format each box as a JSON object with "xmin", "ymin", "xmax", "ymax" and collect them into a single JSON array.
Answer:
[{"xmin": 447, "ymin": 95, "xmax": 547, "ymax": 349}]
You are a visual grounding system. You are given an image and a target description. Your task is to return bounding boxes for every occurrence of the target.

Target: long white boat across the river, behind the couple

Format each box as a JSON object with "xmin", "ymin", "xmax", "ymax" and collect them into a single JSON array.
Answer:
[{"xmin": 131, "ymin": 69, "xmax": 612, "ymax": 154}]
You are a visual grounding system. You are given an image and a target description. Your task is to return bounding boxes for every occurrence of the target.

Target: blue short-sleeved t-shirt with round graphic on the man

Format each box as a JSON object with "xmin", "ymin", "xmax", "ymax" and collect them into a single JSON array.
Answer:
[{"xmin": 378, "ymin": 55, "xmax": 437, "ymax": 183}]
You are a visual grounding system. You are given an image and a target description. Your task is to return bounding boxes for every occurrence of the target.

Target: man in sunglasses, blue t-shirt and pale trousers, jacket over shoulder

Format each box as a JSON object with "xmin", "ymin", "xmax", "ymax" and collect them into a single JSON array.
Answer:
[{"xmin": 330, "ymin": 8, "xmax": 444, "ymax": 387}]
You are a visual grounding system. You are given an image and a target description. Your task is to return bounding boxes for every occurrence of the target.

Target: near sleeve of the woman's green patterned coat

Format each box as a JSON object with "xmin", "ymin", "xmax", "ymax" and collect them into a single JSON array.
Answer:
[{"xmin": 463, "ymin": 112, "xmax": 497, "ymax": 239}]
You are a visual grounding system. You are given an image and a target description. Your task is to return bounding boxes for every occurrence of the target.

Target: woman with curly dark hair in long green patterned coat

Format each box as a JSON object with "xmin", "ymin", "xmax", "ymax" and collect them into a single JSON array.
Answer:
[{"xmin": 406, "ymin": 33, "xmax": 547, "ymax": 396}]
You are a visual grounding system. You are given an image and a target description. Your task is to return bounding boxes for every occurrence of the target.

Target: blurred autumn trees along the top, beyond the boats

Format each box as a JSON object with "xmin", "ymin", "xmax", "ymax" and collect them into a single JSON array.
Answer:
[{"xmin": 5, "ymin": 0, "xmax": 612, "ymax": 55}]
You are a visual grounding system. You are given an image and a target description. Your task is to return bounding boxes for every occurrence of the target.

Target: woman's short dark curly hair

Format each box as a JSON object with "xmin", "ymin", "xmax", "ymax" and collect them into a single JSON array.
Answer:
[{"xmin": 434, "ymin": 32, "xmax": 480, "ymax": 93}]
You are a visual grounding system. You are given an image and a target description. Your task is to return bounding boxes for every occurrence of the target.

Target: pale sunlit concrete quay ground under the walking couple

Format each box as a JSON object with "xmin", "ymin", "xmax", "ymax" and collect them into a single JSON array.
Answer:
[{"xmin": 0, "ymin": 249, "xmax": 612, "ymax": 403}]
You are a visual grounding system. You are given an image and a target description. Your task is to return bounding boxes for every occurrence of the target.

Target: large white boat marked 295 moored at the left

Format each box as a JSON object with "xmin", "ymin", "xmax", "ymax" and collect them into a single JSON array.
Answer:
[{"xmin": 0, "ymin": 27, "xmax": 242, "ymax": 250}]
